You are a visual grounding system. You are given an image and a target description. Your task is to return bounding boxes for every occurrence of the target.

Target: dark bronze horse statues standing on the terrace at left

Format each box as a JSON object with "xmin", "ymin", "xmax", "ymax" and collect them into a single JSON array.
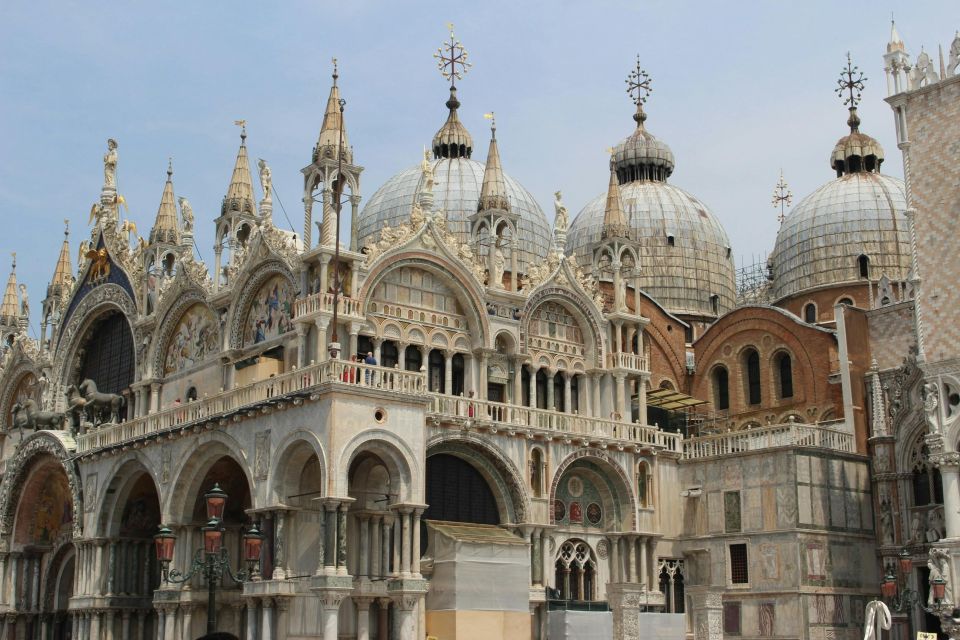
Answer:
[{"xmin": 11, "ymin": 378, "xmax": 127, "ymax": 432}]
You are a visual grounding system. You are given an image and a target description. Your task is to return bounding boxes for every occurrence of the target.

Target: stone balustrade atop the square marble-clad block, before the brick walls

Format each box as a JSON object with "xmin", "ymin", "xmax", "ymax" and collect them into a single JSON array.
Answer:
[{"xmin": 683, "ymin": 420, "xmax": 856, "ymax": 460}]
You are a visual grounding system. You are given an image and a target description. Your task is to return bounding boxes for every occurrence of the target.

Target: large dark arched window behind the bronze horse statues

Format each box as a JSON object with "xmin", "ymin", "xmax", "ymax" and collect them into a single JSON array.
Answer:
[{"xmin": 77, "ymin": 312, "xmax": 134, "ymax": 393}]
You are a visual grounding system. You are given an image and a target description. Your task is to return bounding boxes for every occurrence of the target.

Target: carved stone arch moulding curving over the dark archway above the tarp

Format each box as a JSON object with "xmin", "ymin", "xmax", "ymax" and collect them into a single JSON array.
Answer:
[{"xmin": 427, "ymin": 434, "xmax": 530, "ymax": 524}]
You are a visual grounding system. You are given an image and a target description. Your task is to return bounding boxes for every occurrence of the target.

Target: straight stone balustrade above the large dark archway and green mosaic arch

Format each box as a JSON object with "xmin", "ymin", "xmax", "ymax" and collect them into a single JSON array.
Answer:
[{"xmin": 427, "ymin": 393, "xmax": 683, "ymax": 453}]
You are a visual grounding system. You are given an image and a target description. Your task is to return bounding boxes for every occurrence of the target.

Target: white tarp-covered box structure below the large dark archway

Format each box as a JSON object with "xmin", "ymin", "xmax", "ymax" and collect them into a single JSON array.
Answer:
[{"xmin": 427, "ymin": 522, "xmax": 530, "ymax": 613}]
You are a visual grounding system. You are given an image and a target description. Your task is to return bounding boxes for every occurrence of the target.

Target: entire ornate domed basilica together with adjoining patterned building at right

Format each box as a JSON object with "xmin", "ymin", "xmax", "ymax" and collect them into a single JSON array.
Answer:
[{"xmin": 0, "ymin": 22, "xmax": 960, "ymax": 640}]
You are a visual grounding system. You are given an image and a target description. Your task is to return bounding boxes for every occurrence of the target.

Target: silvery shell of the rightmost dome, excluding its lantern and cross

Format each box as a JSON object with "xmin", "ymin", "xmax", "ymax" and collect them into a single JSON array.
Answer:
[{"xmin": 770, "ymin": 171, "xmax": 910, "ymax": 300}]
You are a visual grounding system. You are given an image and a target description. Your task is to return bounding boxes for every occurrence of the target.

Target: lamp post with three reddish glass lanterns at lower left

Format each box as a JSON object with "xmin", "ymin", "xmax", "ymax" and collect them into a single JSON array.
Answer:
[{"xmin": 153, "ymin": 484, "xmax": 263, "ymax": 634}]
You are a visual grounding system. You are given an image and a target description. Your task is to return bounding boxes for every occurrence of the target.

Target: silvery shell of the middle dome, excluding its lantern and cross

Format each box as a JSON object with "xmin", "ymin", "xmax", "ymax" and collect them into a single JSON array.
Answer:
[{"xmin": 567, "ymin": 180, "xmax": 736, "ymax": 316}]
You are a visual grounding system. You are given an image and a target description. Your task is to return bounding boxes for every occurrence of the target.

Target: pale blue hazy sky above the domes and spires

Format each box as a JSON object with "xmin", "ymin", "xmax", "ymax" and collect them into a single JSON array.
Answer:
[{"xmin": 0, "ymin": 0, "xmax": 960, "ymax": 335}]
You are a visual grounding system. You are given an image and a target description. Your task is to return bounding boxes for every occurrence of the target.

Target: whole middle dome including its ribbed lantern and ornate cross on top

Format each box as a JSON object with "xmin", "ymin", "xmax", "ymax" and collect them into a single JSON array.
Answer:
[{"xmin": 567, "ymin": 58, "xmax": 736, "ymax": 317}]
